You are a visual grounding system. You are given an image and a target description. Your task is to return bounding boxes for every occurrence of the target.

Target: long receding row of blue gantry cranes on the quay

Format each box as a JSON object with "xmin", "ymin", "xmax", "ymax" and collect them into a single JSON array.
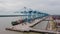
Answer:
[{"xmin": 21, "ymin": 7, "xmax": 49, "ymax": 22}]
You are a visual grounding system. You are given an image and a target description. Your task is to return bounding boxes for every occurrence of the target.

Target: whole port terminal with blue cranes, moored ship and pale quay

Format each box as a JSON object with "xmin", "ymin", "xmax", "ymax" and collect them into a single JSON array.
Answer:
[{"xmin": 5, "ymin": 8, "xmax": 60, "ymax": 34}]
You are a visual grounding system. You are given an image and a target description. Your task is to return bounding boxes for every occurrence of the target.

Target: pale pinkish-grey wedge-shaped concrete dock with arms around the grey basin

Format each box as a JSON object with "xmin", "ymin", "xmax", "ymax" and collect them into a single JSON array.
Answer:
[{"xmin": 6, "ymin": 17, "xmax": 60, "ymax": 34}]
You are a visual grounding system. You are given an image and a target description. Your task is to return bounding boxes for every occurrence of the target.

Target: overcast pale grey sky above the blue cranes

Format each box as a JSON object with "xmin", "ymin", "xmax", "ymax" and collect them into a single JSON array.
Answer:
[{"xmin": 0, "ymin": 0, "xmax": 60, "ymax": 15}]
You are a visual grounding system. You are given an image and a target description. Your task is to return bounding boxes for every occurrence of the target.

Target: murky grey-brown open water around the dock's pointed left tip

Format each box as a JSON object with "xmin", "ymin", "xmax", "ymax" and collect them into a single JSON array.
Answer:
[{"xmin": 0, "ymin": 16, "xmax": 47, "ymax": 34}]
